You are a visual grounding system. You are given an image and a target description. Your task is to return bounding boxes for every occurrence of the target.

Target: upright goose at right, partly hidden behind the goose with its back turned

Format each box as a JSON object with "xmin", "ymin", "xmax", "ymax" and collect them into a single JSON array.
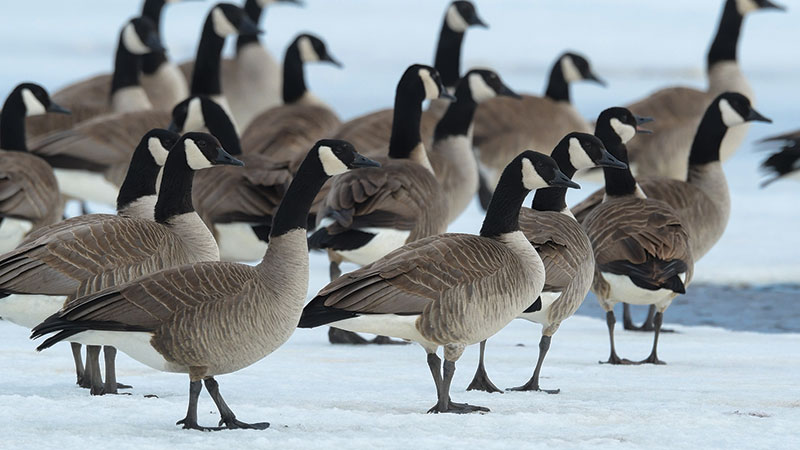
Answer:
[{"xmin": 572, "ymin": 92, "xmax": 771, "ymax": 331}]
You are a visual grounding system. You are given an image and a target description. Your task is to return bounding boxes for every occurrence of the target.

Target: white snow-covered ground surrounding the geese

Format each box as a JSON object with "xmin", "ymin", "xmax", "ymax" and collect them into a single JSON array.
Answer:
[{"xmin": 0, "ymin": 0, "xmax": 800, "ymax": 448}]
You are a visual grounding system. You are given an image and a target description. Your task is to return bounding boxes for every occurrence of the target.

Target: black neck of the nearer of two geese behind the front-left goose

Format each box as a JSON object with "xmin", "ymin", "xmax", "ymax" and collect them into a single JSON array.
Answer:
[{"xmin": 155, "ymin": 149, "xmax": 194, "ymax": 223}]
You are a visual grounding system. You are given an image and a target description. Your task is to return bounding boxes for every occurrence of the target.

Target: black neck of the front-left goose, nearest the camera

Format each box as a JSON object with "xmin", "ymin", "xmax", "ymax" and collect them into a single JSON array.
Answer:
[{"xmin": 270, "ymin": 152, "xmax": 329, "ymax": 237}]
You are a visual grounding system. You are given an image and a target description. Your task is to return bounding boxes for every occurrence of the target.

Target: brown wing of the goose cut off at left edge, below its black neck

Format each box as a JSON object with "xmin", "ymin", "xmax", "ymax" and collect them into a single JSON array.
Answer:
[{"xmin": 0, "ymin": 150, "xmax": 61, "ymax": 226}]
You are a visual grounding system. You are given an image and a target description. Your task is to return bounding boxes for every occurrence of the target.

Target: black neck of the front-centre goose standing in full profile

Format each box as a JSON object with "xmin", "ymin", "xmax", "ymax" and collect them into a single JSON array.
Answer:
[{"xmin": 481, "ymin": 158, "xmax": 529, "ymax": 237}]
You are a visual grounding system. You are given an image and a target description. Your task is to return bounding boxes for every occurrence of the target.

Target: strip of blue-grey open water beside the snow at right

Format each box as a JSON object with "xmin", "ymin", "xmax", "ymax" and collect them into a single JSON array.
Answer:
[{"xmin": 577, "ymin": 284, "xmax": 800, "ymax": 333}]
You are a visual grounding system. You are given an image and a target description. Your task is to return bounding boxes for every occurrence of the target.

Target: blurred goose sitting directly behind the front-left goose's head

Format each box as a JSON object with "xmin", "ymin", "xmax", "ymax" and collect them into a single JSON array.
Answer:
[{"xmin": 242, "ymin": 33, "xmax": 342, "ymax": 167}]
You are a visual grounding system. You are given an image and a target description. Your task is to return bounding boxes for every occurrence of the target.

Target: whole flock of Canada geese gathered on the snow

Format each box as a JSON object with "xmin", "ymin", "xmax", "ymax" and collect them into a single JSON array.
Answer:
[{"xmin": 0, "ymin": 0, "xmax": 800, "ymax": 430}]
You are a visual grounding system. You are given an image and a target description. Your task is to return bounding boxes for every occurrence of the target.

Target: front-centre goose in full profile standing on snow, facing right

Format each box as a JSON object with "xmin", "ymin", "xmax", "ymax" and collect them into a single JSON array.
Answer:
[{"xmin": 298, "ymin": 151, "xmax": 579, "ymax": 413}]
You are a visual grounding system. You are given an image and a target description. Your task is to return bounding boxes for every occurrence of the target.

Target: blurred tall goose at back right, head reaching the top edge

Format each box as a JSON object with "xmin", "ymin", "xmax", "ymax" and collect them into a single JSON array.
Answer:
[{"xmin": 628, "ymin": 0, "xmax": 783, "ymax": 180}]
